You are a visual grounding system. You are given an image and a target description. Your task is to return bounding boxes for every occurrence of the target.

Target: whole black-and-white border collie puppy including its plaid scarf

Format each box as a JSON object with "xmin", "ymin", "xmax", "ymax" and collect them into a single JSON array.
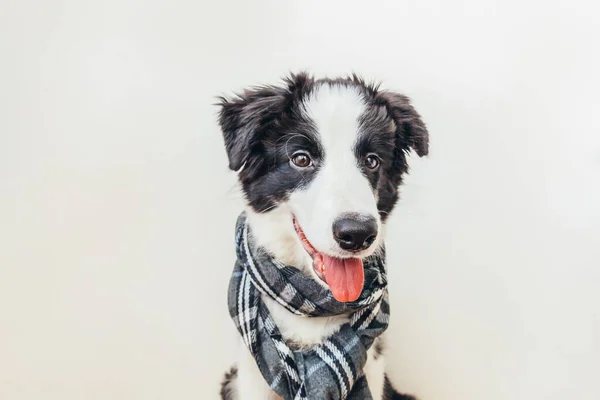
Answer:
[{"xmin": 219, "ymin": 73, "xmax": 429, "ymax": 400}]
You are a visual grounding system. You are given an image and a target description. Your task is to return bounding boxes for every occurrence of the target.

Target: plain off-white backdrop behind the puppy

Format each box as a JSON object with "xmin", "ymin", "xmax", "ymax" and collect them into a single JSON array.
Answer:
[{"xmin": 0, "ymin": 0, "xmax": 600, "ymax": 400}]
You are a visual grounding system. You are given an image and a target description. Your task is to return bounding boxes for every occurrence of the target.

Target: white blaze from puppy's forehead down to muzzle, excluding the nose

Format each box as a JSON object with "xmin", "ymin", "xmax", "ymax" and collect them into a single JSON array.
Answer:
[{"xmin": 289, "ymin": 85, "xmax": 381, "ymax": 257}]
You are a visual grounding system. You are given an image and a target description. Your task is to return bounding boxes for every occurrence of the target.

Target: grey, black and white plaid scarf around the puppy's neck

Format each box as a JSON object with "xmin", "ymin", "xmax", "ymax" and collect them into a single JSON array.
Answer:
[{"xmin": 228, "ymin": 214, "xmax": 389, "ymax": 400}]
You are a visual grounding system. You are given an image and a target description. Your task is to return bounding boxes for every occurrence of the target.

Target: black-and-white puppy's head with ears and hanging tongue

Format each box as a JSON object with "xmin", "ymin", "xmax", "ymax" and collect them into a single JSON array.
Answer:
[{"xmin": 219, "ymin": 74, "xmax": 429, "ymax": 301}]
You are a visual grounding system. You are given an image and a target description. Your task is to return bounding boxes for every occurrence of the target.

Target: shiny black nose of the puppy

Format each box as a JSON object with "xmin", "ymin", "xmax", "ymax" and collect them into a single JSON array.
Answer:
[{"xmin": 333, "ymin": 214, "xmax": 377, "ymax": 251}]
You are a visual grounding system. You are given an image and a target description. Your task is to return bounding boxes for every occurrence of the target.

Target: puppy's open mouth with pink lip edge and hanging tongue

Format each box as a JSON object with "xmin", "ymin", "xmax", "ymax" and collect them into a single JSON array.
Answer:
[{"xmin": 293, "ymin": 217, "xmax": 365, "ymax": 303}]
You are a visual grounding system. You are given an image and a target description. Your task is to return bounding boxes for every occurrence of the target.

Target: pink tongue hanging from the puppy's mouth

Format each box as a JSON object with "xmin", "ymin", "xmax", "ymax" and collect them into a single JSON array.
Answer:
[{"xmin": 323, "ymin": 255, "xmax": 365, "ymax": 303}]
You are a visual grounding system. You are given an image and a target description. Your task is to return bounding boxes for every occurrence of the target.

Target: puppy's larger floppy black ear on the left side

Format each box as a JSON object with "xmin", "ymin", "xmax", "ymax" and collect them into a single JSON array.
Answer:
[{"xmin": 218, "ymin": 73, "xmax": 312, "ymax": 171}]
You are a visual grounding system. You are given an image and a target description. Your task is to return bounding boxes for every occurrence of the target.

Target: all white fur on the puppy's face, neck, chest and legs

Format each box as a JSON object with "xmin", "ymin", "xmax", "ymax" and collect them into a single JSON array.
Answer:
[{"xmin": 234, "ymin": 85, "xmax": 384, "ymax": 400}]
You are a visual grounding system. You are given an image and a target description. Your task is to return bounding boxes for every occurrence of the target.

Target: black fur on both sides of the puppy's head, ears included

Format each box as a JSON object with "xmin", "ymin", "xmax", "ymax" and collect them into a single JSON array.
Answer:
[{"xmin": 219, "ymin": 73, "xmax": 429, "ymax": 220}]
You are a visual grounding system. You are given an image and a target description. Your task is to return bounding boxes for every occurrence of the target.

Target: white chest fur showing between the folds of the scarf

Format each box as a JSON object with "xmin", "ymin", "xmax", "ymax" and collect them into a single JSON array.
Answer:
[{"xmin": 262, "ymin": 296, "xmax": 348, "ymax": 348}]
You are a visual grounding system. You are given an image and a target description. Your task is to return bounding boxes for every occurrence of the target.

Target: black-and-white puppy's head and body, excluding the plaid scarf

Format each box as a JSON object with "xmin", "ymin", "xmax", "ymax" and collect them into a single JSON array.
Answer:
[{"xmin": 218, "ymin": 73, "xmax": 429, "ymax": 400}]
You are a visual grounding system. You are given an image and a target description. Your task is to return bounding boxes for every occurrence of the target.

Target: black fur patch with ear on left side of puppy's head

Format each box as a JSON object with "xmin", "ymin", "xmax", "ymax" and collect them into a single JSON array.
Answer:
[{"xmin": 219, "ymin": 75, "xmax": 323, "ymax": 212}]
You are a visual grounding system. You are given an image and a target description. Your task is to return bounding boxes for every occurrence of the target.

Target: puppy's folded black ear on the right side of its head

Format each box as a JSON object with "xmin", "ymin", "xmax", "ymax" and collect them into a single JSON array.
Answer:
[{"xmin": 377, "ymin": 92, "xmax": 429, "ymax": 157}]
